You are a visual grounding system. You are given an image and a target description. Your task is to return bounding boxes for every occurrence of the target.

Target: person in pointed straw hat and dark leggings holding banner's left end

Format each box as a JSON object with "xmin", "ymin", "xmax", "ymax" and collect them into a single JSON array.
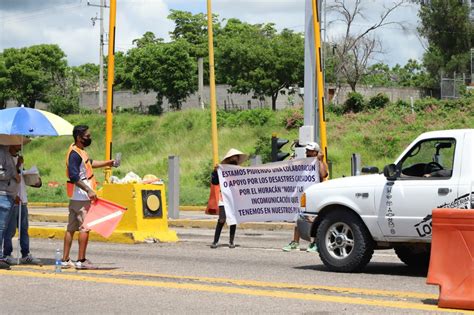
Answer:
[{"xmin": 211, "ymin": 149, "xmax": 248, "ymax": 248}]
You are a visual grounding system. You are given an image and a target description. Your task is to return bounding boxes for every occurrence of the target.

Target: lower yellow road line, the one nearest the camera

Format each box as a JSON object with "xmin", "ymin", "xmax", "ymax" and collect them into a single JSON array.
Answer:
[{"xmin": 0, "ymin": 270, "xmax": 462, "ymax": 314}]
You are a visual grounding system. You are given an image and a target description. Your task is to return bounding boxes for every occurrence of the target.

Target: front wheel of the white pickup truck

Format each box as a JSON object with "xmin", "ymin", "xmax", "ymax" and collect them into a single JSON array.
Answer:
[{"xmin": 316, "ymin": 210, "xmax": 374, "ymax": 272}]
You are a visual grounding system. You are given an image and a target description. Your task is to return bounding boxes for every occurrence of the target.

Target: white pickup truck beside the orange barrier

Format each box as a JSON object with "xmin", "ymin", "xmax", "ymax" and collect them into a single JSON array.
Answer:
[{"xmin": 297, "ymin": 129, "xmax": 474, "ymax": 272}]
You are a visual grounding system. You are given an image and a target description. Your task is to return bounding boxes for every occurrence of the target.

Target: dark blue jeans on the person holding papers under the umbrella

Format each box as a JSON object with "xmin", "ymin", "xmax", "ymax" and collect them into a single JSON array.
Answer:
[{"xmin": 3, "ymin": 204, "xmax": 30, "ymax": 257}]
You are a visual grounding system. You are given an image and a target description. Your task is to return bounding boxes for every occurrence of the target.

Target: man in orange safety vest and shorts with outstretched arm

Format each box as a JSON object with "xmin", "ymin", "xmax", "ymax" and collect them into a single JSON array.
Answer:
[{"xmin": 61, "ymin": 125, "xmax": 115, "ymax": 269}]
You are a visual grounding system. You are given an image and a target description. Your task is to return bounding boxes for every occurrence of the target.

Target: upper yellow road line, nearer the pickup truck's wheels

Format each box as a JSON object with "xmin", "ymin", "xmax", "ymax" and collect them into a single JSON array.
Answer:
[{"xmin": 14, "ymin": 266, "xmax": 438, "ymax": 300}]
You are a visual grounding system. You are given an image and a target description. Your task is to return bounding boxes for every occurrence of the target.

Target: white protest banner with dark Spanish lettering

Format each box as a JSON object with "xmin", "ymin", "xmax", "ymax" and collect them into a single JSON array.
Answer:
[{"xmin": 218, "ymin": 158, "xmax": 319, "ymax": 225}]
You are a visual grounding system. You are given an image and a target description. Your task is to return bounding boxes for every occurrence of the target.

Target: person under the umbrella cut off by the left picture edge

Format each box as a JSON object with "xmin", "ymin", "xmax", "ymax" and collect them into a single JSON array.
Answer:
[{"xmin": 0, "ymin": 145, "xmax": 20, "ymax": 269}]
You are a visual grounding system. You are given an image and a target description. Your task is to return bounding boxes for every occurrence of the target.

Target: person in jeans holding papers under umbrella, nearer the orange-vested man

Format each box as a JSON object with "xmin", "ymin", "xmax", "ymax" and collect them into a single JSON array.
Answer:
[{"xmin": 3, "ymin": 145, "xmax": 42, "ymax": 265}]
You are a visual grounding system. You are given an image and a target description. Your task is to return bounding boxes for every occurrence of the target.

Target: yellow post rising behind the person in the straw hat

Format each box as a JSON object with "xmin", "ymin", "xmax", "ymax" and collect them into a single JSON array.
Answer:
[{"xmin": 207, "ymin": 0, "xmax": 219, "ymax": 165}]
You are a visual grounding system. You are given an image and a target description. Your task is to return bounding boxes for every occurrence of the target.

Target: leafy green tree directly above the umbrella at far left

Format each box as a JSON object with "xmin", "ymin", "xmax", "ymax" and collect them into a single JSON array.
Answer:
[{"xmin": 3, "ymin": 45, "xmax": 67, "ymax": 108}]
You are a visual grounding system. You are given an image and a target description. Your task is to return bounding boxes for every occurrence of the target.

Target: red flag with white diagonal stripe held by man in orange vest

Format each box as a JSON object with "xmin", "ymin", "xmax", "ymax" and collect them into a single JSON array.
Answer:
[{"xmin": 83, "ymin": 198, "xmax": 127, "ymax": 238}]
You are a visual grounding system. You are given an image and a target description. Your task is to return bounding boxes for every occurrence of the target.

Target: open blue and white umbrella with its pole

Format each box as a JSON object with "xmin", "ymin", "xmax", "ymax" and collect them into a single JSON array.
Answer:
[{"xmin": 0, "ymin": 105, "xmax": 74, "ymax": 263}]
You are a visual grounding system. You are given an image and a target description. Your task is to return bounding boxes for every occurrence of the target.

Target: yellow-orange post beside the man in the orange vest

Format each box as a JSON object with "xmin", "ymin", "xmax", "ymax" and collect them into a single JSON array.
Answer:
[{"xmin": 104, "ymin": 0, "xmax": 117, "ymax": 183}]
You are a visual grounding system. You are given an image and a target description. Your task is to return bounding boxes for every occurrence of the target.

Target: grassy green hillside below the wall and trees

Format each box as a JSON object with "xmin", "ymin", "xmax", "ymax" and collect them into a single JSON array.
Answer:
[{"xmin": 24, "ymin": 100, "xmax": 474, "ymax": 205}]
